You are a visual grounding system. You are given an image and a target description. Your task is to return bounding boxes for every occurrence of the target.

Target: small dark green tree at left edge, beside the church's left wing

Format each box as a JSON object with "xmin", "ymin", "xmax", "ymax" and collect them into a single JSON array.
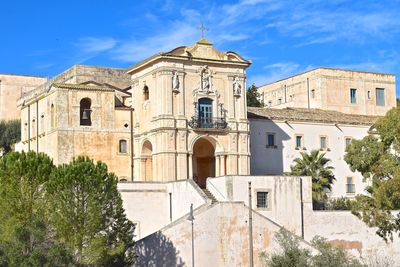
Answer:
[{"xmin": 0, "ymin": 120, "xmax": 21, "ymax": 153}]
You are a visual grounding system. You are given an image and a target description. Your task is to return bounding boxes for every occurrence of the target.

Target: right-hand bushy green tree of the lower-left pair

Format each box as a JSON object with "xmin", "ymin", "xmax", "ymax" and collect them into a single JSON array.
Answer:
[{"xmin": 47, "ymin": 157, "xmax": 134, "ymax": 266}]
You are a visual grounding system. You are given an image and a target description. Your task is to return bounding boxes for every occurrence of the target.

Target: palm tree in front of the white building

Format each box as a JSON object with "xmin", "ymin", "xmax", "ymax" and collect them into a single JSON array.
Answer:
[{"xmin": 290, "ymin": 150, "xmax": 335, "ymax": 208}]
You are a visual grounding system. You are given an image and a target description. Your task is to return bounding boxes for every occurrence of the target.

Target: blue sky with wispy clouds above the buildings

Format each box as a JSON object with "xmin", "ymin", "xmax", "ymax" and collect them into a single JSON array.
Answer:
[{"xmin": 0, "ymin": 0, "xmax": 400, "ymax": 95}]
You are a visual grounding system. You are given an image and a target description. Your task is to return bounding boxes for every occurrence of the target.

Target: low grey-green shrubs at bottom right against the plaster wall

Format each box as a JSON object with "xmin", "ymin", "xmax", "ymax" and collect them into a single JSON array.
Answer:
[{"xmin": 262, "ymin": 228, "xmax": 363, "ymax": 267}]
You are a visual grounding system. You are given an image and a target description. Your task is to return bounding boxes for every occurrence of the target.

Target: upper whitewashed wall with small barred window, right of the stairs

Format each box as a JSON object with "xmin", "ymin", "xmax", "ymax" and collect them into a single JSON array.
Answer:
[{"xmin": 207, "ymin": 176, "xmax": 312, "ymax": 235}]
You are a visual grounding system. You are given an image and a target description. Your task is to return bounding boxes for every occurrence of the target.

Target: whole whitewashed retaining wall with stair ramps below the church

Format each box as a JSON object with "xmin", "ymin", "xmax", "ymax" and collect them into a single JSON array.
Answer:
[{"xmin": 129, "ymin": 176, "xmax": 400, "ymax": 266}]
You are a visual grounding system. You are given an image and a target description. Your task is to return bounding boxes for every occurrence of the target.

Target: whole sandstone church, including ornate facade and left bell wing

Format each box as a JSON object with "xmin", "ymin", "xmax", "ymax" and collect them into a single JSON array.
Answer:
[{"xmin": 19, "ymin": 39, "xmax": 251, "ymax": 187}]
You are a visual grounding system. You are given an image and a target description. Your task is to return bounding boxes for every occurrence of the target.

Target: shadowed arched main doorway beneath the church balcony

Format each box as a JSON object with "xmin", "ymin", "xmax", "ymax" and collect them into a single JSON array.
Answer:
[{"xmin": 193, "ymin": 138, "xmax": 215, "ymax": 188}]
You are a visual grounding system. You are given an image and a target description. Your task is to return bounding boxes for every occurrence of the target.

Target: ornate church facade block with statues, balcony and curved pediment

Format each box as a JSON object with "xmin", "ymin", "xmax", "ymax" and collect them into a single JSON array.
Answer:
[{"xmin": 128, "ymin": 39, "xmax": 250, "ymax": 186}]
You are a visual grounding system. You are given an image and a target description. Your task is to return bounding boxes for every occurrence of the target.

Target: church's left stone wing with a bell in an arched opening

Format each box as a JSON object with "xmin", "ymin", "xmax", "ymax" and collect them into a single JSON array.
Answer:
[{"xmin": 19, "ymin": 65, "xmax": 131, "ymax": 179}]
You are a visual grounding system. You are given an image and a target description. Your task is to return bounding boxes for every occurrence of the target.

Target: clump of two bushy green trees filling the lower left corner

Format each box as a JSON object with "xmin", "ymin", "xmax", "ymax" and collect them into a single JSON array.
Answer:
[{"xmin": 0, "ymin": 152, "xmax": 135, "ymax": 266}]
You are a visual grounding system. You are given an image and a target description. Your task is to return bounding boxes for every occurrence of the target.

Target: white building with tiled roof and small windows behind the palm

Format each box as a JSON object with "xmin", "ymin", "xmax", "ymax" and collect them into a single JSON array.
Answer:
[{"xmin": 248, "ymin": 108, "xmax": 379, "ymax": 197}]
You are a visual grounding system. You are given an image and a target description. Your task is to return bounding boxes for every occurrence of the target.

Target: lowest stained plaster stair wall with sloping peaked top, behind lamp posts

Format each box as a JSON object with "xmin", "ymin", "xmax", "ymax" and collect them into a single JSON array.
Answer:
[{"xmin": 136, "ymin": 202, "xmax": 309, "ymax": 266}]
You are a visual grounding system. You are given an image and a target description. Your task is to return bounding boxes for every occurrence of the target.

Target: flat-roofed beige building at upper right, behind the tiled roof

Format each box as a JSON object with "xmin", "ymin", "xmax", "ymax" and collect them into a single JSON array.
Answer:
[{"xmin": 258, "ymin": 68, "xmax": 396, "ymax": 116}]
